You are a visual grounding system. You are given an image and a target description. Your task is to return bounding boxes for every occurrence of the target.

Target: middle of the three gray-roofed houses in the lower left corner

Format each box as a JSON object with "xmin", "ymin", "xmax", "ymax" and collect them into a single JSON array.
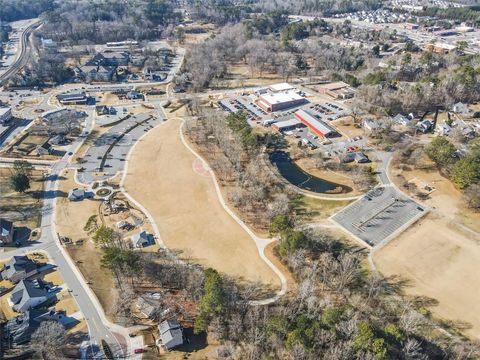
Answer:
[{"xmin": 10, "ymin": 279, "xmax": 49, "ymax": 312}]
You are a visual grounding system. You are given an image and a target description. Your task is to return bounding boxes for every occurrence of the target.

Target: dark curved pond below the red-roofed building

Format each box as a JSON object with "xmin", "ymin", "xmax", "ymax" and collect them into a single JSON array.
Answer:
[{"xmin": 270, "ymin": 151, "xmax": 352, "ymax": 193}]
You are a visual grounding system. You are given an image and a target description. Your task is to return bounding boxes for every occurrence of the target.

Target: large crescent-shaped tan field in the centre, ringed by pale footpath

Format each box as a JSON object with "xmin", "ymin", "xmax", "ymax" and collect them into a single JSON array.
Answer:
[{"xmin": 125, "ymin": 119, "xmax": 279, "ymax": 287}]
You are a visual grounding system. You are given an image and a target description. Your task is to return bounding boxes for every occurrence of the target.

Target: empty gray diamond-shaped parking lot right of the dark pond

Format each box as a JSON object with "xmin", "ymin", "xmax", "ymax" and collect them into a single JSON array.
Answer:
[{"xmin": 332, "ymin": 186, "xmax": 427, "ymax": 247}]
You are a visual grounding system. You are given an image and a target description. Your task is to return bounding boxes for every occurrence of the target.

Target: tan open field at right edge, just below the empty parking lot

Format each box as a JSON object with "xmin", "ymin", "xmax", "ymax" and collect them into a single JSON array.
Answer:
[{"xmin": 374, "ymin": 214, "xmax": 480, "ymax": 338}]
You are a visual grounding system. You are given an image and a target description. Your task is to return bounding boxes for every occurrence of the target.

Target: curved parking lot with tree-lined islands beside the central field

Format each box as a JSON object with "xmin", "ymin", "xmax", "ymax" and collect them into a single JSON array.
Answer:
[{"xmin": 78, "ymin": 113, "xmax": 163, "ymax": 184}]
